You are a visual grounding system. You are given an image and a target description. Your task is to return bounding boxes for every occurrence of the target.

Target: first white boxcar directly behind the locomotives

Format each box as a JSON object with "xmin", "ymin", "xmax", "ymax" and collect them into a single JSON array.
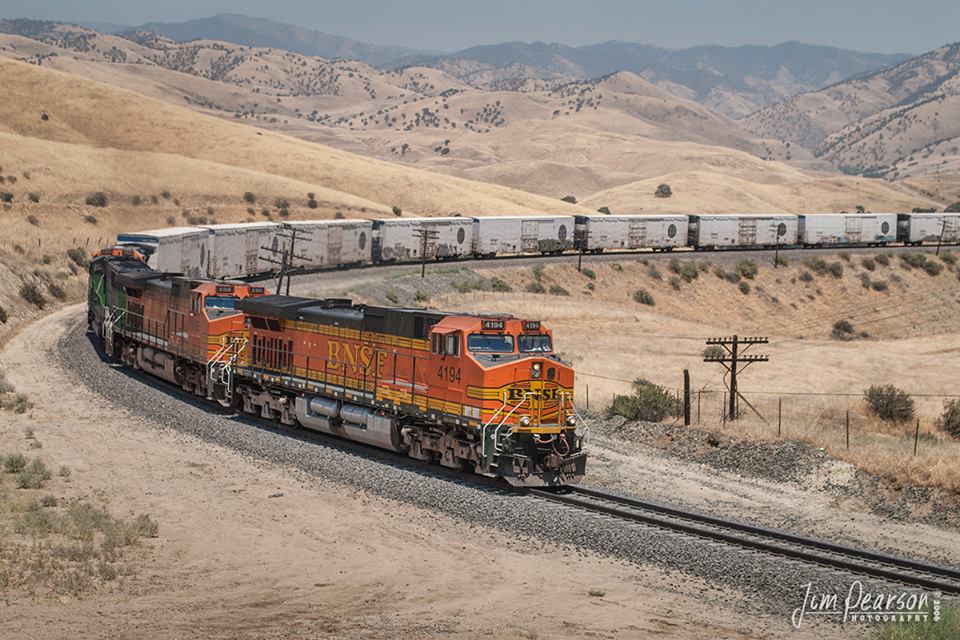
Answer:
[{"xmin": 117, "ymin": 227, "xmax": 209, "ymax": 278}]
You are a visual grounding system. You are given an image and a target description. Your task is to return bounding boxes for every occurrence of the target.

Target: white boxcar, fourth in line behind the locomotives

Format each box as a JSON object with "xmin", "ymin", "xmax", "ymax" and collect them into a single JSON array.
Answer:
[{"xmin": 372, "ymin": 217, "xmax": 473, "ymax": 262}]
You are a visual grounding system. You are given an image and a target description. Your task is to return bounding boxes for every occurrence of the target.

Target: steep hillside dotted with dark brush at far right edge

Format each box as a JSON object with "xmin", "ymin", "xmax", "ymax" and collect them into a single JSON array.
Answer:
[{"xmin": 742, "ymin": 43, "xmax": 960, "ymax": 186}]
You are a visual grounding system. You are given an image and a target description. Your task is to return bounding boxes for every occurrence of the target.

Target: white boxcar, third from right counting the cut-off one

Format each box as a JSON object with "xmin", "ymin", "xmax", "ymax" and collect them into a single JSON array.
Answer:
[{"xmin": 688, "ymin": 213, "xmax": 799, "ymax": 249}]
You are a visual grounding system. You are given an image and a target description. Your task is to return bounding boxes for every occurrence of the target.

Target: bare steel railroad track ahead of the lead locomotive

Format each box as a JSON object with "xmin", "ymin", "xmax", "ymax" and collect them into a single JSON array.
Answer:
[{"xmin": 527, "ymin": 487, "xmax": 960, "ymax": 595}]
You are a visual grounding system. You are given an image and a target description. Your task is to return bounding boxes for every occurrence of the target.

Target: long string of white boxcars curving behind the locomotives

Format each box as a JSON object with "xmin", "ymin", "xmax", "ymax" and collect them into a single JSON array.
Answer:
[{"xmin": 117, "ymin": 213, "xmax": 960, "ymax": 278}]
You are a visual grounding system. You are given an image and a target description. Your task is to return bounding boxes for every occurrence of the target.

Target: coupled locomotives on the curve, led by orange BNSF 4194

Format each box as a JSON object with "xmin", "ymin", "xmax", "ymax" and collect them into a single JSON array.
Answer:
[{"xmin": 88, "ymin": 247, "xmax": 586, "ymax": 486}]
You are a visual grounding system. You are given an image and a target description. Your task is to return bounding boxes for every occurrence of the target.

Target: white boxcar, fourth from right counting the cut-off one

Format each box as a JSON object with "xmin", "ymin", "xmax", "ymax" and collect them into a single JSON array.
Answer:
[{"xmin": 575, "ymin": 214, "xmax": 689, "ymax": 253}]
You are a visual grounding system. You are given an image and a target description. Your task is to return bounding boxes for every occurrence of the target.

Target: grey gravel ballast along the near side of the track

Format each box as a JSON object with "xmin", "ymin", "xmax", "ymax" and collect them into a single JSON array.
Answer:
[{"xmin": 58, "ymin": 316, "xmax": 900, "ymax": 615}]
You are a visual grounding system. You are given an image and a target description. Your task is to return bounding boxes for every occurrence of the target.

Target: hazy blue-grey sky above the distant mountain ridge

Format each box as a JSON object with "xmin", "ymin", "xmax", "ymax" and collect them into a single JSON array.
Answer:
[{"xmin": 0, "ymin": 0, "xmax": 960, "ymax": 53}]
